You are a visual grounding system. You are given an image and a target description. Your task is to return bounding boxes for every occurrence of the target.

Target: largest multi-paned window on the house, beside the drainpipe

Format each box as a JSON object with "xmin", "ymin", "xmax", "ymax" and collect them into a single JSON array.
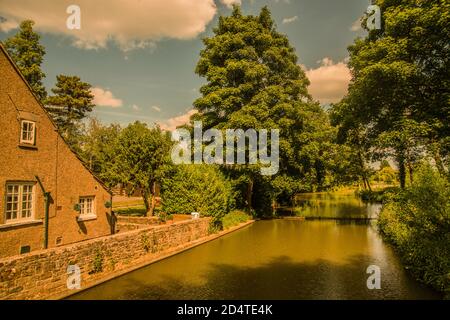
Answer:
[{"xmin": 6, "ymin": 183, "xmax": 34, "ymax": 223}]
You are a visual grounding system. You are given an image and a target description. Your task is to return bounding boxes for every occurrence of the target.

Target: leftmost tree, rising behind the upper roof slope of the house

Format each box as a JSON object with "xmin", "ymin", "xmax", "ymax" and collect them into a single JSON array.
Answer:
[{"xmin": 5, "ymin": 20, "xmax": 47, "ymax": 101}]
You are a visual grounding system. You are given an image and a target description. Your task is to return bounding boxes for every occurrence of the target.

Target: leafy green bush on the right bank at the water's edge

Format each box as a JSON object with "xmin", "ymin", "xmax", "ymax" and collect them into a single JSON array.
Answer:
[{"xmin": 378, "ymin": 166, "xmax": 450, "ymax": 296}]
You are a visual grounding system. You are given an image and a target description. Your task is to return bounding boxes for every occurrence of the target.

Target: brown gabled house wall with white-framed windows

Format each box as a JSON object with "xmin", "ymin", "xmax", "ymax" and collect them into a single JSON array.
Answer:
[{"xmin": 0, "ymin": 45, "xmax": 114, "ymax": 258}]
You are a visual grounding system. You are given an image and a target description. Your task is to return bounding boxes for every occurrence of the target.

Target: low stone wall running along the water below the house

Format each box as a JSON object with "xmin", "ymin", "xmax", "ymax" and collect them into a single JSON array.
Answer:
[{"xmin": 0, "ymin": 218, "xmax": 209, "ymax": 299}]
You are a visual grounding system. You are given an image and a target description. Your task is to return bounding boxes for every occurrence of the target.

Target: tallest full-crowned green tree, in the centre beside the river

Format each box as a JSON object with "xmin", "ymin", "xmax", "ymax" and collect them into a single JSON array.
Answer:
[{"xmin": 193, "ymin": 6, "xmax": 334, "ymax": 214}]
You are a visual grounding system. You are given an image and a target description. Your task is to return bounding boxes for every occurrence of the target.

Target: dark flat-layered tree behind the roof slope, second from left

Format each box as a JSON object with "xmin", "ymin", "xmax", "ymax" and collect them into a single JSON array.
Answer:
[{"xmin": 45, "ymin": 75, "xmax": 95, "ymax": 148}]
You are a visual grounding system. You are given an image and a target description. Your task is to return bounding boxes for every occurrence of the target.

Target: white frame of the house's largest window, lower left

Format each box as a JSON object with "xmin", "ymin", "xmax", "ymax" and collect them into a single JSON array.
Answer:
[{"xmin": 5, "ymin": 182, "xmax": 36, "ymax": 224}]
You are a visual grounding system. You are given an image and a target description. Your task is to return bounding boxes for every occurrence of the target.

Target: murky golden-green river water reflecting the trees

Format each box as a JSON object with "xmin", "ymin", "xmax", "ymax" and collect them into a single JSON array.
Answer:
[{"xmin": 71, "ymin": 194, "xmax": 440, "ymax": 299}]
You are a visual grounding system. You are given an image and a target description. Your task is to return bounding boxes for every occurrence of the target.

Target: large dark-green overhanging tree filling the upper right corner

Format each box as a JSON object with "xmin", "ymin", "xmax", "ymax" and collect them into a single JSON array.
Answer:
[{"xmin": 336, "ymin": 0, "xmax": 450, "ymax": 187}]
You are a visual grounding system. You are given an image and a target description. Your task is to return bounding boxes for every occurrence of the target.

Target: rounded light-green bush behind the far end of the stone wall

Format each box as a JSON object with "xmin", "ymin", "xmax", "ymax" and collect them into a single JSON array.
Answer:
[{"xmin": 161, "ymin": 165, "xmax": 234, "ymax": 220}]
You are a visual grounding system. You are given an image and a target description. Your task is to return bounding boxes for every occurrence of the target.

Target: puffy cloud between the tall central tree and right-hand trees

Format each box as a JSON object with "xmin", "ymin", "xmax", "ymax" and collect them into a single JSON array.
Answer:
[{"xmin": 305, "ymin": 58, "xmax": 351, "ymax": 104}]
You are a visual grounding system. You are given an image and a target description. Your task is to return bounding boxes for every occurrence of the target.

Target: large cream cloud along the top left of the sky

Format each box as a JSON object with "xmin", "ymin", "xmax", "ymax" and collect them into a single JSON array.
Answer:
[{"xmin": 0, "ymin": 0, "xmax": 218, "ymax": 51}]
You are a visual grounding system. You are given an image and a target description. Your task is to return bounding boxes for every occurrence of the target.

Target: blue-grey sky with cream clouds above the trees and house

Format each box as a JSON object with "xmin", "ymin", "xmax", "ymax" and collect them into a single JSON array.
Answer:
[{"xmin": 0, "ymin": 0, "xmax": 370, "ymax": 130}]
